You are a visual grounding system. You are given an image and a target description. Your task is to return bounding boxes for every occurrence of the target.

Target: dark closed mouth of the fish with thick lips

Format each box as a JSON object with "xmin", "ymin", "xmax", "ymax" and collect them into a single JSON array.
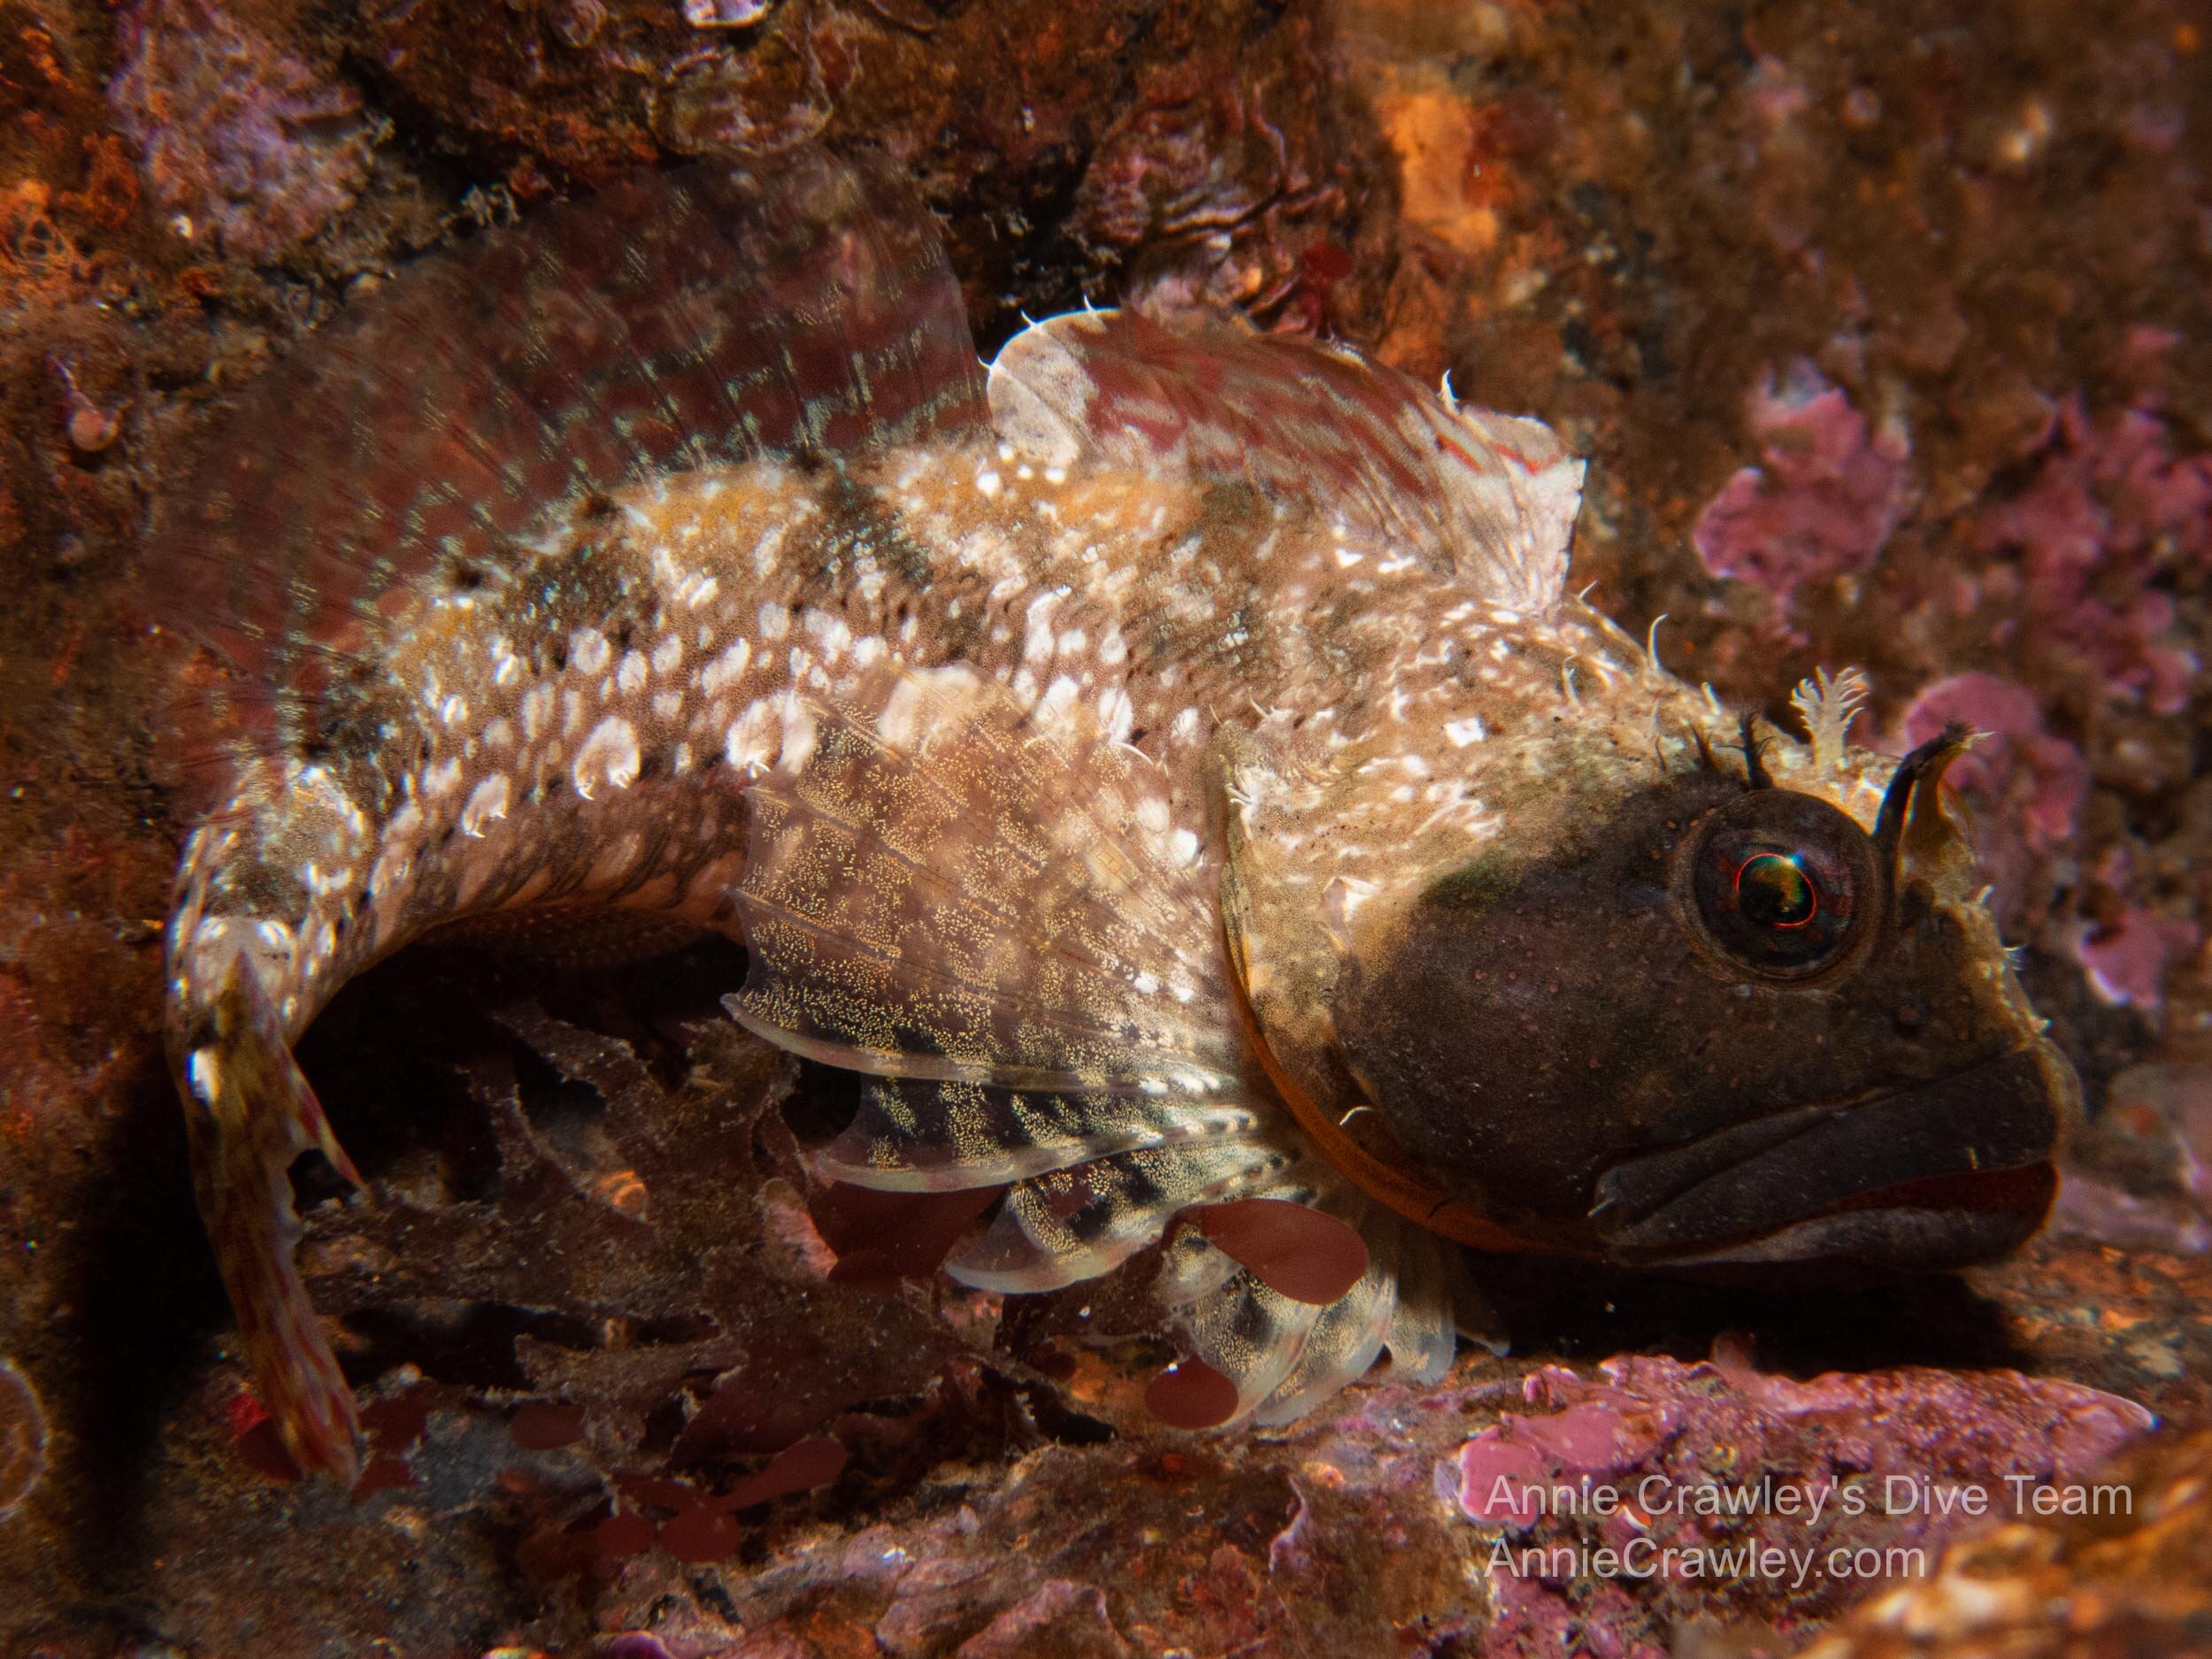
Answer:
[{"xmin": 1591, "ymin": 1044, "xmax": 2079, "ymax": 1277}]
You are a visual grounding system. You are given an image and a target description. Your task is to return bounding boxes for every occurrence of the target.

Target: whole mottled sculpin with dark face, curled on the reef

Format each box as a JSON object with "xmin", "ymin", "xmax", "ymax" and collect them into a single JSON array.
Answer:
[{"xmin": 150, "ymin": 153, "xmax": 2078, "ymax": 1476}]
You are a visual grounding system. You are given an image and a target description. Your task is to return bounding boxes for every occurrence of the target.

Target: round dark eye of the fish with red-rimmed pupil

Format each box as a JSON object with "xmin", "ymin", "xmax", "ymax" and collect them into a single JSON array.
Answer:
[{"xmin": 1688, "ymin": 790, "xmax": 1880, "ymax": 980}]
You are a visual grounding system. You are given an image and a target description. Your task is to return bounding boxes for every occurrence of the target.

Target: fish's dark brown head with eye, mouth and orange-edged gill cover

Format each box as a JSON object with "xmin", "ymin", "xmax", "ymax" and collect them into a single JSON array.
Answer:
[{"xmin": 1228, "ymin": 708, "xmax": 2079, "ymax": 1277}]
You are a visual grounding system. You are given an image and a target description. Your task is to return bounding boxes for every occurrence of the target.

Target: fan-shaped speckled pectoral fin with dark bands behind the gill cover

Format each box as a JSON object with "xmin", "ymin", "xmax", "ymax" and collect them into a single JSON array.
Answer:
[{"xmin": 730, "ymin": 671, "xmax": 1451, "ymax": 1427}]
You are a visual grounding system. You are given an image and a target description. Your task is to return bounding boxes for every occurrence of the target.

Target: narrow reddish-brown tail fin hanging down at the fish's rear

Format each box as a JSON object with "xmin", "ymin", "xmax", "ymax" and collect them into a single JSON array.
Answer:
[{"xmin": 175, "ymin": 960, "xmax": 361, "ymax": 1485}]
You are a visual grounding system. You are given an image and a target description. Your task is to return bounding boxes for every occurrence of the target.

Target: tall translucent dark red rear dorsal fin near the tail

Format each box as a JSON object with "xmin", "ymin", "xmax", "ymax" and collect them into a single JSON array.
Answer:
[{"xmin": 144, "ymin": 150, "xmax": 985, "ymax": 774}]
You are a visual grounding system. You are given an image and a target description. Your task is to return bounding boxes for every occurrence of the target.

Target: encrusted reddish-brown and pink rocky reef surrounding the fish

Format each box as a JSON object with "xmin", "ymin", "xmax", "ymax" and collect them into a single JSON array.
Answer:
[{"xmin": 0, "ymin": 0, "xmax": 2212, "ymax": 1659}]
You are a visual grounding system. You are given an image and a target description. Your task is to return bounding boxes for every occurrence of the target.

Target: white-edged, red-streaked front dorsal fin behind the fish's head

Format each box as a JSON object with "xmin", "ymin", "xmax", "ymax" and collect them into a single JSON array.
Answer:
[{"xmin": 991, "ymin": 312, "xmax": 1582, "ymax": 611}]
